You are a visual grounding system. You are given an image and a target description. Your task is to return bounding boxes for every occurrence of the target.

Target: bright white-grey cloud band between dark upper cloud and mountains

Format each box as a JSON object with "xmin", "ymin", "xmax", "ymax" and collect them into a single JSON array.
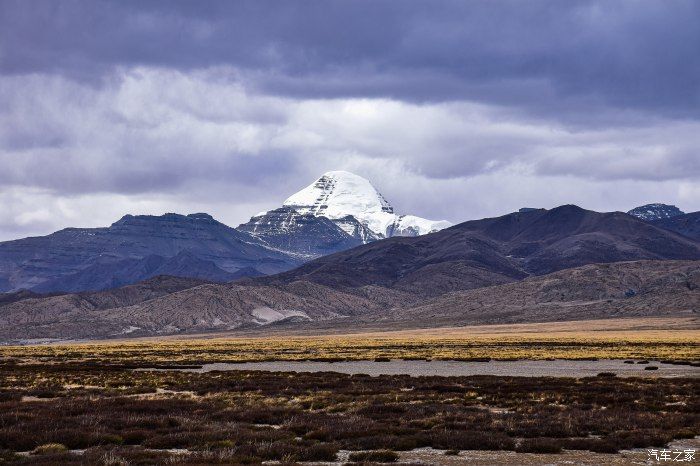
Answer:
[{"xmin": 0, "ymin": 68, "xmax": 700, "ymax": 239}]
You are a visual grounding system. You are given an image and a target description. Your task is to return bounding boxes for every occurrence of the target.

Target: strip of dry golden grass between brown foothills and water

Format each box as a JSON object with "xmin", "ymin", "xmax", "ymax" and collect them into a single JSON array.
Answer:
[{"xmin": 0, "ymin": 319, "xmax": 700, "ymax": 364}]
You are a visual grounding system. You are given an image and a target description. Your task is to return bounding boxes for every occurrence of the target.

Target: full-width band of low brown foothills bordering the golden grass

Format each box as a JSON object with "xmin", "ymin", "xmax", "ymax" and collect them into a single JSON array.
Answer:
[{"xmin": 0, "ymin": 261, "xmax": 700, "ymax": 342}]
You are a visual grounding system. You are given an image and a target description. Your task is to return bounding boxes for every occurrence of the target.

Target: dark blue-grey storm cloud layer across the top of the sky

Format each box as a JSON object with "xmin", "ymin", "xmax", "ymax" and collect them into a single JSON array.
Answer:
[{"xmin": 0, "ymin": 0, "xmax": 700, "ymax": 123}]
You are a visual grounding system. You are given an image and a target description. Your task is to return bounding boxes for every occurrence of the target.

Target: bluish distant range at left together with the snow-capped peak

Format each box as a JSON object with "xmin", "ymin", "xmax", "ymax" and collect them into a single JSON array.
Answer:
[{"xmin": 0, "ymin": 172, "xmax": 450, "ymax": 293}]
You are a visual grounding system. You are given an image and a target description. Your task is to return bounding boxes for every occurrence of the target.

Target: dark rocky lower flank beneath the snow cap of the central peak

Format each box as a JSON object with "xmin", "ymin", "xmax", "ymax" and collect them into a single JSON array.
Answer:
[{"xmin": 237, "ymin": 207, "xmax": 365, "ymax": 259}]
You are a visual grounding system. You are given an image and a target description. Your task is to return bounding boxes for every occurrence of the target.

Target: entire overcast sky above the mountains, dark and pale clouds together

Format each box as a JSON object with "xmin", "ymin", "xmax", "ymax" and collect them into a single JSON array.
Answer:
[{"xmin": 0, "ymin": 0, "xmax": 700, "ymax": 240}]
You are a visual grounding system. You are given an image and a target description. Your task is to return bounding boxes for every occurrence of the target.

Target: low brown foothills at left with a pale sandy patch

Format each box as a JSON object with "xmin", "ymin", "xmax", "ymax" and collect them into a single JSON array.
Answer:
[{"xmin": 0, "ymin": 277, "xmax": 416, "ymax": 342}]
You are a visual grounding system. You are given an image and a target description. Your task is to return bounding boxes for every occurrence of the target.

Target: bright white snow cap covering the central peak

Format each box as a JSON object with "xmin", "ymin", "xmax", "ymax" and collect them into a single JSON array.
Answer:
[{"xmin": 284, "ymin": 171, "xmax": 451, "ymax": 238}]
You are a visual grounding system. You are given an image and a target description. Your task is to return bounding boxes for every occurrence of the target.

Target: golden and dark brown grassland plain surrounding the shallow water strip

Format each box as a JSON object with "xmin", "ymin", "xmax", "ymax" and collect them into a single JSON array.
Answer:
[{"xmin": 0, "ymin": 319, "xmax": 700, "ymax": 465}]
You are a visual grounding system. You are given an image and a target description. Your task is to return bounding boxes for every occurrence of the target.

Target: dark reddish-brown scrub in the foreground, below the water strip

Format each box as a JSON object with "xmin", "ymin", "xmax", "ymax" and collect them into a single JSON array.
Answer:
[{"xmin": 0, "ymin": 356, "xmax": 700, "ymax": 464}]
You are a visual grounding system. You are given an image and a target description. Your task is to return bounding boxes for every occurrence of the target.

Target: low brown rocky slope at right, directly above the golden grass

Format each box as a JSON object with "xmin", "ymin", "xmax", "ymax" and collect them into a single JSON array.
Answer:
[{"xmin": 388, "ymin": 261, "xmax": 700, "ymax": 325}]
